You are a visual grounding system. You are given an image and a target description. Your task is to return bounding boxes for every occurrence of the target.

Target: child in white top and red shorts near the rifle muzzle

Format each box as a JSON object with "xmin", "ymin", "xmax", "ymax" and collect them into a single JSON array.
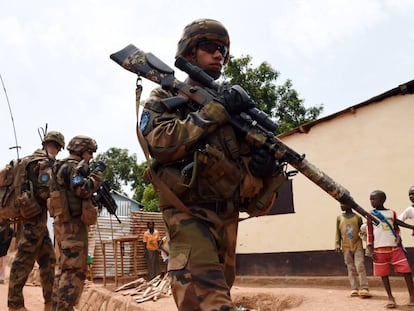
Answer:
[{"xmin": 367, "ymin": 190, "xmax": 414, "ymax": 309}]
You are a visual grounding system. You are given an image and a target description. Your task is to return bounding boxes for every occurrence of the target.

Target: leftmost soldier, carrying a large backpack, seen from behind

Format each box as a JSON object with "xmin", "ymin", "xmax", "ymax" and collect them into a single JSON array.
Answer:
[{"xmin": 7, "ymin": 131, "xmax": 65, "ymax": 310}]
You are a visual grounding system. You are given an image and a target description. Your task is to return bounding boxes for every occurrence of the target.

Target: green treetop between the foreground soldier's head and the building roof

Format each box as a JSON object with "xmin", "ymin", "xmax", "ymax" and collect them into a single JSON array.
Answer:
[{"xmin": 222, "ymin": 55, "xmax": 323, "ymax": 134}]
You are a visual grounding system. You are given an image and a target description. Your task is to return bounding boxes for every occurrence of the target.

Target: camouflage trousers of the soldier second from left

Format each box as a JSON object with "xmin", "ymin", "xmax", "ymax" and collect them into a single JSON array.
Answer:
[{"xmin": 52, "ymin": 218, "xmax": 88, "ymax": 311}]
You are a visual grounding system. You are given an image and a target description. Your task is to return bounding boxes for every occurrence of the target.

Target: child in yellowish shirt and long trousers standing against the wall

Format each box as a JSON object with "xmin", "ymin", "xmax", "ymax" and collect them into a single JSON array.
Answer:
[{"xmin": 335, "ymin": 203, "xmax": 371, "ymax": 298}]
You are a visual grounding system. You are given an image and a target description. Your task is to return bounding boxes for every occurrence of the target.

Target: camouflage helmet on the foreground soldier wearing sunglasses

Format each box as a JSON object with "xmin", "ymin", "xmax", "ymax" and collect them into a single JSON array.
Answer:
[{"xmin": 175, "ymin": 18, "xmax": 230, "ymax": 64}]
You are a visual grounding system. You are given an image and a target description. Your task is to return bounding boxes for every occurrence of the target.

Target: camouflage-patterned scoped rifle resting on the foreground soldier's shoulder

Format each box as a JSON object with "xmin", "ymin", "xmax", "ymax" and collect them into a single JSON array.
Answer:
[{"xmin": 110, "ymin": 44, "xmax": 414, "ymax": 229}]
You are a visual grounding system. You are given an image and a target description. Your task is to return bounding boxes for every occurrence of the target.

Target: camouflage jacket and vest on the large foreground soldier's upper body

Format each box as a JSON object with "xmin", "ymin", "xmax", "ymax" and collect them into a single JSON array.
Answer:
[{"xmin": 139, "ymin": 80, "xmax": 284, "ymax": 212}]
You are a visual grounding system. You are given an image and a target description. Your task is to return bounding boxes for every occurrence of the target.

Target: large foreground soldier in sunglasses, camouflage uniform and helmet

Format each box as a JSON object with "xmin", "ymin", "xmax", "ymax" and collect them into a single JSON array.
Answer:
[{"xmin": 139, "ymin": 19, "xmax": 286, "ymax": 311}]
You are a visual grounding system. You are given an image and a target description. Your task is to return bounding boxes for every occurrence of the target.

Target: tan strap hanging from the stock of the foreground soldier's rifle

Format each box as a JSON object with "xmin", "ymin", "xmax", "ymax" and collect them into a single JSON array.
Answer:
[{"xmin": 135, "ymin": 84, "xmax": 195, "ymax": 216}]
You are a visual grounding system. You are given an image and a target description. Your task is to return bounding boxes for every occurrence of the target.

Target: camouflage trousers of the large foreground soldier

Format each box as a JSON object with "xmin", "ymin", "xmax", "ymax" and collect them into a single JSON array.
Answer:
[{"xmin": 163, "ymin": 204, "xmax": 239, "ymax": 311}]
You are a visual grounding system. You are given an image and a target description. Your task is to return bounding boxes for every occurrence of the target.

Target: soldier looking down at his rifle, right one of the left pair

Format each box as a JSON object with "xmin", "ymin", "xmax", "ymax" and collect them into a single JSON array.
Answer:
[{"xmin": 48, "ymin": 135, "xmax": 106, "ymax": 311}]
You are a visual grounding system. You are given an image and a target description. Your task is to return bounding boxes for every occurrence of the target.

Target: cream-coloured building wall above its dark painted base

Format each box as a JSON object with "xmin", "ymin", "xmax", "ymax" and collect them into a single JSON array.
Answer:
[{"xmin": 237, "ymin": 95, "xmax": 414, "ymax": 254}]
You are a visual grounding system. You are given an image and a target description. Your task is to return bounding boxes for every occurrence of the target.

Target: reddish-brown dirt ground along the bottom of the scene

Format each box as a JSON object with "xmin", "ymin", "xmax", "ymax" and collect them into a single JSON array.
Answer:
[{"xmin": 0, "ymin": 278, "xmax": 414, "ymax": 311}]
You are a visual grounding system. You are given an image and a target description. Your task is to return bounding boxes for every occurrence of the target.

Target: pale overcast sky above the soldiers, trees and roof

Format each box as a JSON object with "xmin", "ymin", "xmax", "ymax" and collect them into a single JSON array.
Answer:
[{"xmin": 0, "ymin": 0, "xmax": 414, "ymax": 171}]
